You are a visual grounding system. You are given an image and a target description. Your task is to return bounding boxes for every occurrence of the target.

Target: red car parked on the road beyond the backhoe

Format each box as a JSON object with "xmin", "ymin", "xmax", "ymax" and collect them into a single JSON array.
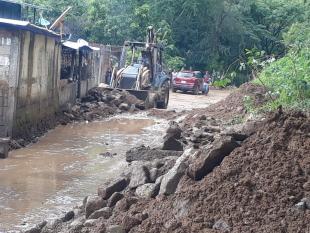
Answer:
[{"xmin": 172, "ymin": 71, "xmax": 204, "ymax": 95}]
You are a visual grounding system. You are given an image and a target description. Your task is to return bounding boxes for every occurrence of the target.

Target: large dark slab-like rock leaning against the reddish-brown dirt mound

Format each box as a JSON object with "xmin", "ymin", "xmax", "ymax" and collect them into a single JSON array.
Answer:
[{"xmin": 188, "ymin": 136, "xmax": 240, "ymax": 180}]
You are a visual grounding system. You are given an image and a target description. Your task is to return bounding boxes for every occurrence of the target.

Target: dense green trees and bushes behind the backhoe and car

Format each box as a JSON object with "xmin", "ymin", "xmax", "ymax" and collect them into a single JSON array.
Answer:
[{"xmin": 28, "ymin": 0, "xmax": 310, "ymax": 108}]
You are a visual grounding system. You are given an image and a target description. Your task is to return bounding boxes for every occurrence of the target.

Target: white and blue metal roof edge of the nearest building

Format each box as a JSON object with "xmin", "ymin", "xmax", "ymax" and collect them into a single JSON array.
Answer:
[{"xmin": 0, "ymin": 18, "xmax": 60, "ymax": 40}]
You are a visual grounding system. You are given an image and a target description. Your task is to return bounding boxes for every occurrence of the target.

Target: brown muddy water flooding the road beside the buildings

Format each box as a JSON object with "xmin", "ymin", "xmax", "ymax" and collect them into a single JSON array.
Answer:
[{"xmin": 0, "ymin": 117, "xmax": 164, "ymax": 233}]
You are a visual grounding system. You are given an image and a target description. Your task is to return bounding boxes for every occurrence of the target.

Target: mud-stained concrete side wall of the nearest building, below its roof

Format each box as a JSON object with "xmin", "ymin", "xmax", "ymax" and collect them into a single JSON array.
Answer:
[{"xmin": 13, "ymin": 31, "xmax": 61, "ymax": 136}]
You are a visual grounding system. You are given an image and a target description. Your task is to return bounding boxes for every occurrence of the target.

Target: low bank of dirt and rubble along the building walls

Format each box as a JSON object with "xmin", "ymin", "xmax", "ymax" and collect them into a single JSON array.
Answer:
[{"xmin": 10, "ymin": 87, "xmax": 145, "ymax": 150}]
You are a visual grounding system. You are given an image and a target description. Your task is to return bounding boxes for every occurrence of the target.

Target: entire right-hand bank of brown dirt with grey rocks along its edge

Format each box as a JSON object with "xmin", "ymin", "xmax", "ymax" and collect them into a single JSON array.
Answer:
[{"xmin": 23, "ymin": 84, "xmax": 310, "ymax": 233}]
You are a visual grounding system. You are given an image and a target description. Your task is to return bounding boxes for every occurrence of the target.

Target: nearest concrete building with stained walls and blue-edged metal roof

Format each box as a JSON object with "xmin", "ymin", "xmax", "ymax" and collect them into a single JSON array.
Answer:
[{"xmin": 0, "ymin": 18, "xmax": 61, "ymax": 140}]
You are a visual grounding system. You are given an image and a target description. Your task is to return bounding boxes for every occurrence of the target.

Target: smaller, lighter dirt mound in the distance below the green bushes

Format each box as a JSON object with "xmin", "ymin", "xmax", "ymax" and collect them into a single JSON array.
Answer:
[{"xmin": 204, "ymin": 83, "xmax": 268, "ymax": 119}]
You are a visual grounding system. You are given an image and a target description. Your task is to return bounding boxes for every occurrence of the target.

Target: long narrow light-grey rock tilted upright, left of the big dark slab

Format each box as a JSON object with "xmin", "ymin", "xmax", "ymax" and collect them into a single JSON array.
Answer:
[{"xmin": 159, "ymin": 149, "xmax": 193, "ymax": 195}]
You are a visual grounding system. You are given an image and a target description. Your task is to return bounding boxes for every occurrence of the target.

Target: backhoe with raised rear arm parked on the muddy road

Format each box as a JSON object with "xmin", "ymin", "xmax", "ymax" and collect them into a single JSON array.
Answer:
[{"xmin": 110, "ymin": 27, "xmax": 169, "ymax": 108}]
